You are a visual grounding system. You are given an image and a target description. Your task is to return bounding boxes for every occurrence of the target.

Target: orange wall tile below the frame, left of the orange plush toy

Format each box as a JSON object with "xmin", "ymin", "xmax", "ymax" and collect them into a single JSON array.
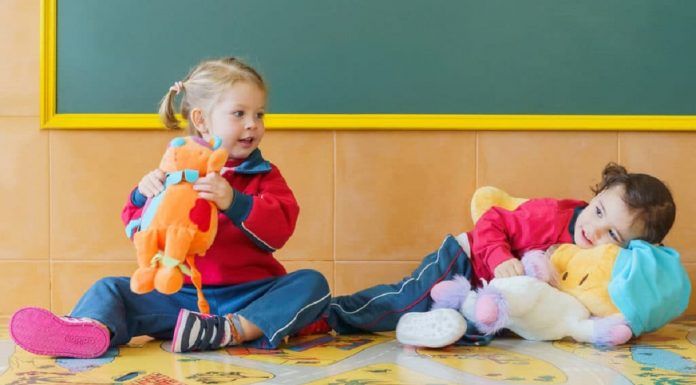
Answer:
[{"xmin": 50, "ymin": 131, "xmax": 180, "ymax": 260}]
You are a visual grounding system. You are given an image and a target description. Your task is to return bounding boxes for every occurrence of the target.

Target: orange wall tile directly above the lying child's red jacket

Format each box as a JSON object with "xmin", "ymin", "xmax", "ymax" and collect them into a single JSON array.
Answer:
[{"xmin": 478, "ymin": 131, "xmax": 617, "ymax": 199}]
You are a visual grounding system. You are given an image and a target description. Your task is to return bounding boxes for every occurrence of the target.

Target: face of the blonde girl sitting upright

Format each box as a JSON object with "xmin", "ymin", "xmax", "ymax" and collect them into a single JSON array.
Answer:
[{"xmin": 203, "ymin": 82, "xmax": 266, "ymax": 160}]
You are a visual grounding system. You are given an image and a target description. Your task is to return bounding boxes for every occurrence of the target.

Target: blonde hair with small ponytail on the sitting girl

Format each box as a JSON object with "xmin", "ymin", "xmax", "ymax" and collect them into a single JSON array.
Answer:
[{"xmin": 159, "ymin": 57, "xmax": 267, "ymax": 136}]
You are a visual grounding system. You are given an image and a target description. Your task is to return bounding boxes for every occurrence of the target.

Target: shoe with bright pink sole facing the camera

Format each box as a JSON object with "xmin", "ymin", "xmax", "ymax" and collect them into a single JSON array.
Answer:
[{"xmin": 10, "ymin": 307, "xmax": 110, "ymax": 358}]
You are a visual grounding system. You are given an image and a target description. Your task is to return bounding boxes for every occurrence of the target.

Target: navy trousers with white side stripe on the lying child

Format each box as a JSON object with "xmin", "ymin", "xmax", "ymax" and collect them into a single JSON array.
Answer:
[{"xmin": 328, "ymin": 235, "xmax": 472, "ymax": 333}]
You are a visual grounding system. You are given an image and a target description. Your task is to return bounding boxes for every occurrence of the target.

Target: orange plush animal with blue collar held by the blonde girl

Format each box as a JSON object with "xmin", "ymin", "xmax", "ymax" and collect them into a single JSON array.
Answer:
[{"xmin": 126, "ymin": 136, "xmax": 227, "ymax": 314}]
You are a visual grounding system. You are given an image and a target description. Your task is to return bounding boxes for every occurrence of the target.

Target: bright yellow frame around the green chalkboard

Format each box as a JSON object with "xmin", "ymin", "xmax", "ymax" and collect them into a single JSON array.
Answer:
[{"xmin": 40, "ymin": 0, "xmax": 696, "ymax": 131}]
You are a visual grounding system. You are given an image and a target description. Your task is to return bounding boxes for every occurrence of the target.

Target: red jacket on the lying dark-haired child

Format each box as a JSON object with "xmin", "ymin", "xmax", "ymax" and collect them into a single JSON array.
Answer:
[{"xmin": 469, "ymin": 198, "xmax": 587, "ymax": 286}]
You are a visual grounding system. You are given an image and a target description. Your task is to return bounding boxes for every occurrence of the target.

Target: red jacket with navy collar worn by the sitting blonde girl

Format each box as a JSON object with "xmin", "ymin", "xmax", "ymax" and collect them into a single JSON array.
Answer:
[{"xmin": 121, "ymin": 149, "xmax": 300, "ymax": 285}]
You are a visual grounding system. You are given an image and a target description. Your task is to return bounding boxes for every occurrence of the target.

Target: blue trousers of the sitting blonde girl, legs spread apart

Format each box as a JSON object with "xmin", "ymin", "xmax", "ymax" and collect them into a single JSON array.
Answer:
[{"xmin": 70, "ymin": 270, "xmax": 331, "ymax": 349}]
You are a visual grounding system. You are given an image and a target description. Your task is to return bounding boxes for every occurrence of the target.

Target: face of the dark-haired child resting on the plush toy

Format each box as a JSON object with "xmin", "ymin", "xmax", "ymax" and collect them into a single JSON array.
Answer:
[{"xmin": 574, "ymin": 185, "xmax": 643, "ymax": 248}]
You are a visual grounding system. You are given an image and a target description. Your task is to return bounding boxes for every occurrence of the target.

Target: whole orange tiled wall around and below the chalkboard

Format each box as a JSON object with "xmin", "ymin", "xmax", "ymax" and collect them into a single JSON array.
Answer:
[{"xmin": 0, "ymin": 0, "xmax": 696, "ymax": 317}]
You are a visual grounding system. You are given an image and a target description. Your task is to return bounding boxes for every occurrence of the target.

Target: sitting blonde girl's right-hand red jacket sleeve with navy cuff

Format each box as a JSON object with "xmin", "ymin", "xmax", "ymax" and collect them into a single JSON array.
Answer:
[{"xmin": 225, "ymin": 166, "xmax": 300, "ymax": 252}]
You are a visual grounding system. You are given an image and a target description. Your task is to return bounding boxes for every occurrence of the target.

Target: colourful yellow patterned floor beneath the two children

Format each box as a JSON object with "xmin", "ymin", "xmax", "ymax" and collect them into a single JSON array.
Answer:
[{"xmin": 0, "ymin": 320, "xmax": 696, "ymax": 385}]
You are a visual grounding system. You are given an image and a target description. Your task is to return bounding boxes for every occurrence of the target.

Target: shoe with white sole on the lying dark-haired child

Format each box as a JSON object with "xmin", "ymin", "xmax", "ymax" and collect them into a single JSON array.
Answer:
[{"xmin": 396, "ymin": 309, "xmax": 466, "ymax": 348}]
